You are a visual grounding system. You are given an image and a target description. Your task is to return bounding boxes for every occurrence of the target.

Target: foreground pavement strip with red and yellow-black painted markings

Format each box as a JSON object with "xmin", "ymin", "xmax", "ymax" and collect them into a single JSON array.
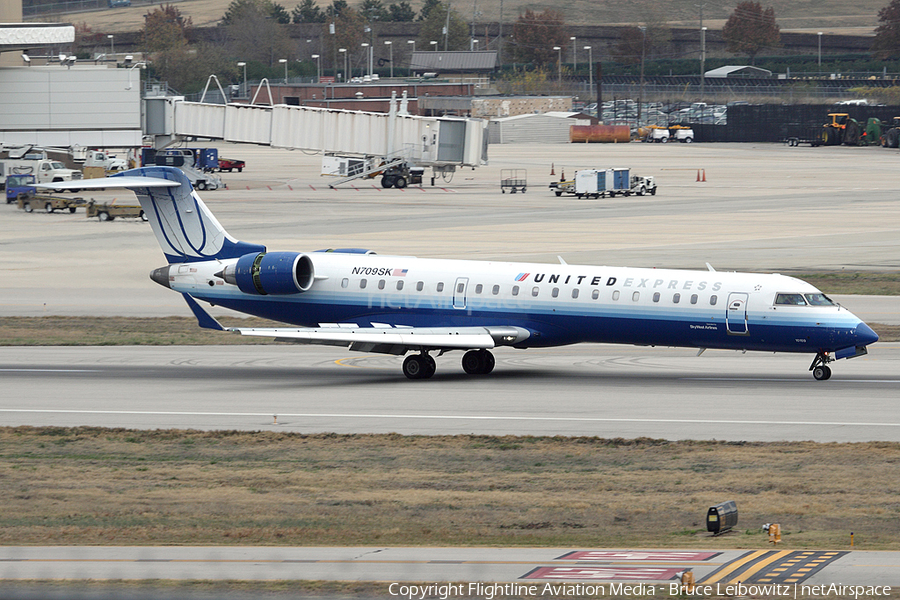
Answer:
[{"xmin": 0, "ymin": 544, "xmax": 900, "ymax": 598}]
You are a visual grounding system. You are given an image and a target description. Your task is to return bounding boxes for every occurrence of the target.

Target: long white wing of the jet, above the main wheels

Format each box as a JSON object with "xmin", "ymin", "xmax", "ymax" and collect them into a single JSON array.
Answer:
[{"xmin": 229, "ymin": 324, "xmax": 530, "ymax": 354}]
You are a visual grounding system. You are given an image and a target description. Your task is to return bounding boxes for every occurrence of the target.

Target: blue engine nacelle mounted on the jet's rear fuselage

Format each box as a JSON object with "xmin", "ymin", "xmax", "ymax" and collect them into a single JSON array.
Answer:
[{"xmin": 222, "ymin": 252, "xmax": 315, "ymax": 296}]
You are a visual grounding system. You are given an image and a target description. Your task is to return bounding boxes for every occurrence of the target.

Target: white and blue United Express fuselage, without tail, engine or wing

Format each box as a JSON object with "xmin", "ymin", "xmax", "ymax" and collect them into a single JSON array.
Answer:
[{"xmin": 158, "ymin": 252, "xmax": 872, "ymax": 353}]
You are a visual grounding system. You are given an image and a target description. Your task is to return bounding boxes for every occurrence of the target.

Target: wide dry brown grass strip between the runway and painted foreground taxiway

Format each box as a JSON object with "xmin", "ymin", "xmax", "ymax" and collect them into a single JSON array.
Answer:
[{"xmin": 0, "ymin": 427, "xmax": 900, "ymax": 550}]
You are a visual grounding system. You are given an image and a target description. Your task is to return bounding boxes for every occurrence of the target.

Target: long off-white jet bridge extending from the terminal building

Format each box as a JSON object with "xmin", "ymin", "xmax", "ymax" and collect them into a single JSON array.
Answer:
[{"xmin": 144, "ymin": 89, "xmax": 488, "ymax": 181}]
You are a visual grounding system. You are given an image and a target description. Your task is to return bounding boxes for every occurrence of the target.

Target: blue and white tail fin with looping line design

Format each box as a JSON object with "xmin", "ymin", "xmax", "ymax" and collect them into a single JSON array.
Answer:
[{"xmin": 114, "ymin": 167, "xmax": 266, "ymax": 263}]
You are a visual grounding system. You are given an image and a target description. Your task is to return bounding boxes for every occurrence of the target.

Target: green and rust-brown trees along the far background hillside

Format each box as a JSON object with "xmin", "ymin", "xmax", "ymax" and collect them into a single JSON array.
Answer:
[{"xmin": 70, "ymin": 0, "xmax": 900, "ymax": 93}]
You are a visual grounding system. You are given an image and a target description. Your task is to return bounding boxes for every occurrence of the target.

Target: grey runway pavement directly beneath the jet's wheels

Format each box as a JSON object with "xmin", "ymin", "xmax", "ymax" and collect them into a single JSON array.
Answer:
[{"xmin": 0, "ymin": 344, "xmax": 900, "ymax": 442}]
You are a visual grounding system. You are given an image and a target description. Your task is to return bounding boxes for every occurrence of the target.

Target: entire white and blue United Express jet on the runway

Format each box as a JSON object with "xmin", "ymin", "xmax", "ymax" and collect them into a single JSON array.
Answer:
[{"xmin": 47, "ymin": 167, "xmax": 878, "ymax": 380}]
